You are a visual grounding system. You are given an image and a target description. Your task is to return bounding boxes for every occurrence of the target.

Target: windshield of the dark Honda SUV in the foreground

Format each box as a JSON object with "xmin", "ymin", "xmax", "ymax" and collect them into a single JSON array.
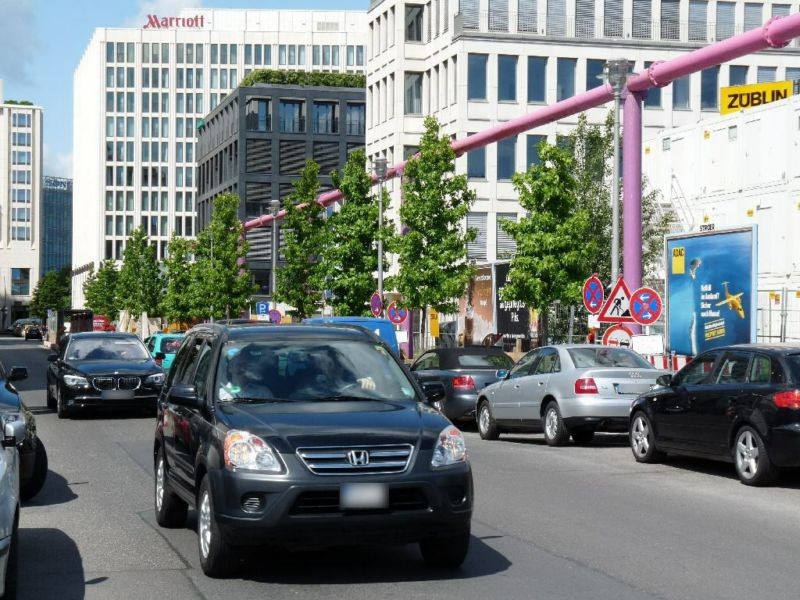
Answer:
[{"xmin": 217, "ymin": 339, "xmax": 415, "ymax": 401}]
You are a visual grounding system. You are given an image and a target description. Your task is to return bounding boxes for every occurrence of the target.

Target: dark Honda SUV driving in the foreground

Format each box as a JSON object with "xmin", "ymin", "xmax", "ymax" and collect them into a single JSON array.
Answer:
[{"xmin": 153, "ymin": 324, "xmax": 473, "ymax": 577}]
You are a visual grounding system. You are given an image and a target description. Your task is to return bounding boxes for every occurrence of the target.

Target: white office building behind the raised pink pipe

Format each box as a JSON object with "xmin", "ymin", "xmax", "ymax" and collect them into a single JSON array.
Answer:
[{"xmin": 367, "ymin": 0, "xmax": 800, "ymax": 262}]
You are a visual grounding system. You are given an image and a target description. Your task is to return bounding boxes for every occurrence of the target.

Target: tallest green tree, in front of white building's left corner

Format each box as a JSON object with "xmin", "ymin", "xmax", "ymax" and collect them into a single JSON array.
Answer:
[{"xmin": 392, "ymin": 117, "xmax": 476, "ymax": 336}]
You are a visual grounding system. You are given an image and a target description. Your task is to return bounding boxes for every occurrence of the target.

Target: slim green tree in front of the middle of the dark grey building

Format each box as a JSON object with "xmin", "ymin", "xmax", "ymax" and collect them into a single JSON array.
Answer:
[{"xmin": 275, "ymin": 160, "xmax": 326, "ymax": 319}]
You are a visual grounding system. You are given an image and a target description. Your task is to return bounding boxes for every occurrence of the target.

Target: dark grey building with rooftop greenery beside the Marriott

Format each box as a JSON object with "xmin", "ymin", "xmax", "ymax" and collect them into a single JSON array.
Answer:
[{"xmin": 197, "ymin": 83, "xmax": 366, "ymax": 295}]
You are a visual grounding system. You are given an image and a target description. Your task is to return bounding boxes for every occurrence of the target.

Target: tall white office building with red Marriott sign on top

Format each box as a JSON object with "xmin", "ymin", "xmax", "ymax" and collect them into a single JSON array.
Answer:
[{"xmin": 72, "ymin": 9, "xmax": 367, "ymax": 307}]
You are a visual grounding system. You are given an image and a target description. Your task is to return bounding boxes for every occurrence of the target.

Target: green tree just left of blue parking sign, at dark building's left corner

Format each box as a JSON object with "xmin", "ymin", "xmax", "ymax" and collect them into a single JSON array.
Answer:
[{"xmin": 191, "ymin": 194, "xmax": 254, "ymax": 319}]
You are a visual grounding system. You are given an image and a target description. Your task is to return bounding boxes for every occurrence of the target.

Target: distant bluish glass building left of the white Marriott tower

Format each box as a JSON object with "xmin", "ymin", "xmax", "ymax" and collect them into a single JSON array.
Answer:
[{"xmin": 39, "ymin": 177, "xmax": 72, "ymax": 277}]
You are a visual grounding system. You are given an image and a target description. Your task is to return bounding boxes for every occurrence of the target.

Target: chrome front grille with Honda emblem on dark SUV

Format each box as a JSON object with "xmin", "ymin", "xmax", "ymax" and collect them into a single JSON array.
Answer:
[{"xmin": 297, "ymin": 444, "xmax": 414, "ymax": 475}]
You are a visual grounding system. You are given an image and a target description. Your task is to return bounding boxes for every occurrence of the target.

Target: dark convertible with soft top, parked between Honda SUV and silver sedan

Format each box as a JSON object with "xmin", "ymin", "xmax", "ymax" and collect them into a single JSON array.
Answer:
[{"xmin": 411, "ymin": 346, "xmax": 514, "ymax": 421}]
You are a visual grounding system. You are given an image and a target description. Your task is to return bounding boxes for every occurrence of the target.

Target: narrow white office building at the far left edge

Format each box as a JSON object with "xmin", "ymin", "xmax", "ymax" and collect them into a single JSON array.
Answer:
[{"xmin": 0, "ymin": 80, "xmax": 42, "ymax": 329}]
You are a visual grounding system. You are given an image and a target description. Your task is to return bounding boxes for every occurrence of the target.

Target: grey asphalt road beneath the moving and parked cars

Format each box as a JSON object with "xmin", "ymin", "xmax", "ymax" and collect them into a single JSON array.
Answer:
[{"xmin": 0, "ymin": 338, "xmax": 800, "ymax": 600}]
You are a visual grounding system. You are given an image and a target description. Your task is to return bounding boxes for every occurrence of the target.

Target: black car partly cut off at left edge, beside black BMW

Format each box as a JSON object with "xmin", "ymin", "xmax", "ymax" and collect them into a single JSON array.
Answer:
[{"xmin": 0, "ymin": 364, "xmax": 47, "ymax": 500}]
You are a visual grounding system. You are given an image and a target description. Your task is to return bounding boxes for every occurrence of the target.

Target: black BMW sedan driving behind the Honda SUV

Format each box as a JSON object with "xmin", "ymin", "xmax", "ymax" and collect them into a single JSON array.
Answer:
[{"xmin": 47, "ymin": 332, "xmax": 164, "ymax": 419}]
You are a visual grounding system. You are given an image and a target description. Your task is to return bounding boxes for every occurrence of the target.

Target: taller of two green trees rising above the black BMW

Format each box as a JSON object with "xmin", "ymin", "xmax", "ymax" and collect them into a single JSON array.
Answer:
[{"xmin": 117, "ymin": 227, "xmax": 164, "ymax": 317}]
